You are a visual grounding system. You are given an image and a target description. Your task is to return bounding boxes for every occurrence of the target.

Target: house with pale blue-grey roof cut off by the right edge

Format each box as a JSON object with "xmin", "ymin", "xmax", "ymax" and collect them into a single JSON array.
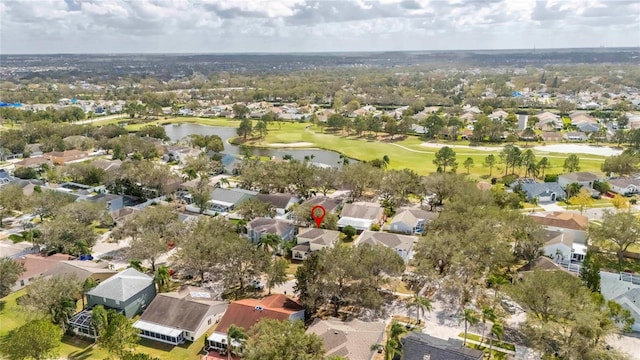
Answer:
[{"xmin": 600, "ymin": 271, "xmax": 640, "ymax": 331}]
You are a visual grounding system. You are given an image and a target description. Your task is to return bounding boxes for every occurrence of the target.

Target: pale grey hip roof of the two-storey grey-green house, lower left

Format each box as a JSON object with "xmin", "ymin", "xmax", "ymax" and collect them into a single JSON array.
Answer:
[{"xmin": 87, "ymin": 268, "xmax": 153, "ymax": 301}]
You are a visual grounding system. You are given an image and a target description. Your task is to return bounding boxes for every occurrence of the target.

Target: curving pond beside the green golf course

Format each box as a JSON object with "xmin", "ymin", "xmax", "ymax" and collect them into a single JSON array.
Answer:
[{"xmin": 164, "ymin": 123, "xmax": 353, "ymax": 167}]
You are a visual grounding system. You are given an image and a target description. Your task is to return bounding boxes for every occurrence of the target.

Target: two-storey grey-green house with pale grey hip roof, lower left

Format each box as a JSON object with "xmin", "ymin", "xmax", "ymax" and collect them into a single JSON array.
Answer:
[{"xmin": 87, "ymin": 268, "xmax": 156, "ymax": 319}]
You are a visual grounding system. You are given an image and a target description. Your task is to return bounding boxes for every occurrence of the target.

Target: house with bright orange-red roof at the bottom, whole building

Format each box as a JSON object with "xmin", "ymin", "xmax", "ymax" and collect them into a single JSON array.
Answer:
[{"xmin": 207, "ymin": 294, "xmax": 304, "ymax": 352}]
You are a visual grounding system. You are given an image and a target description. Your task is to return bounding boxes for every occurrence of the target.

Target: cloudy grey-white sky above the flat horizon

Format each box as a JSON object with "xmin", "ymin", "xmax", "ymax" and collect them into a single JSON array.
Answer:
[{"xmin": 0, "ymin": 0, "xmax": 640, "ymax": 54}]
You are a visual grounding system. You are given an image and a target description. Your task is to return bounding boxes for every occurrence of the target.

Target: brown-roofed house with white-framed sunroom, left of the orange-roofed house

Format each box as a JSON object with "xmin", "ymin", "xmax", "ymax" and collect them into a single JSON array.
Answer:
[{"xmin": 133, "ymin": 287, "xmax": 228, "ymax": 345}]
